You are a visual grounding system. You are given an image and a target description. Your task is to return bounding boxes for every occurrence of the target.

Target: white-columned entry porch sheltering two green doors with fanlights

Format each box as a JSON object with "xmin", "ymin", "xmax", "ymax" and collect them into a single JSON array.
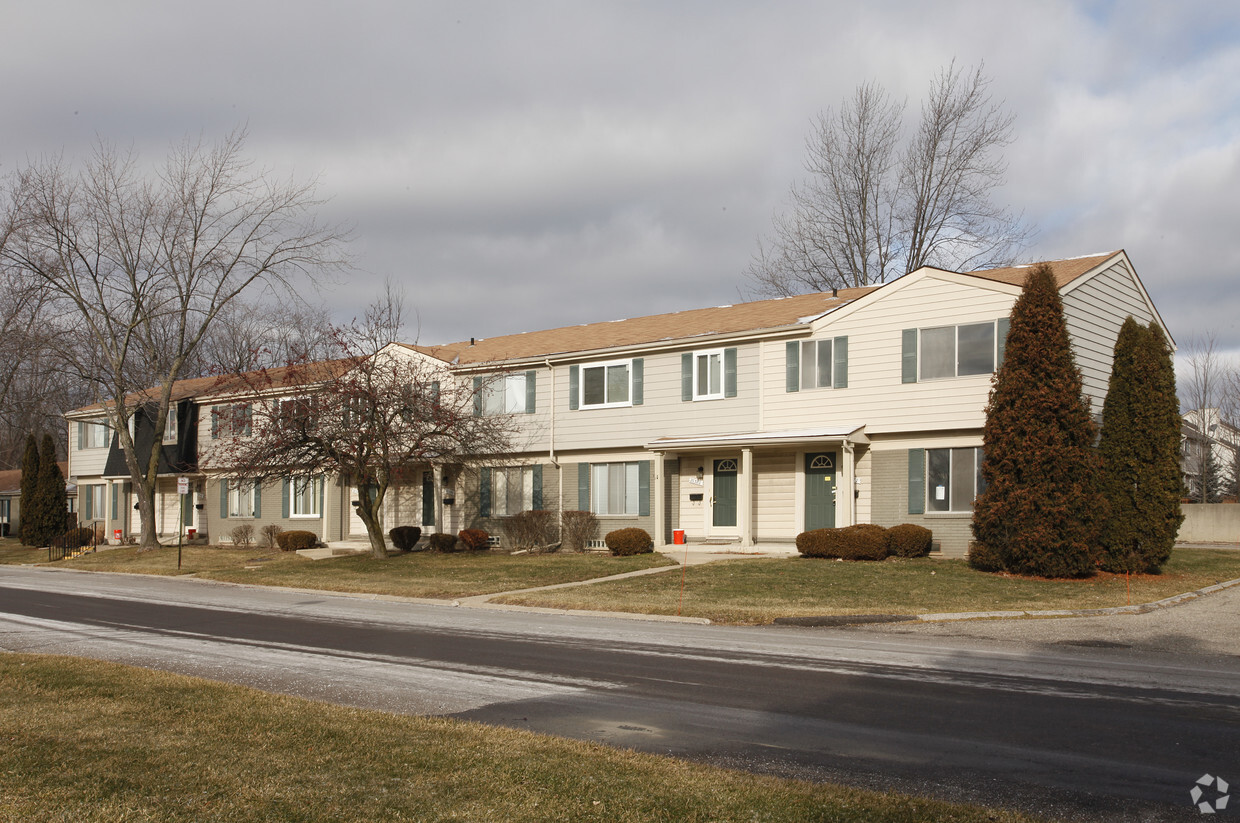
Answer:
[{"xmin": 646, "ymin": 424, "xmax": 869, "ymax": 547}]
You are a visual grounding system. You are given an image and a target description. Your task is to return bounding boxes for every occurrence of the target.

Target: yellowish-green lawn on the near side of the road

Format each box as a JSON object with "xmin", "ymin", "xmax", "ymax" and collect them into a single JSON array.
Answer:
[{"xmin": 0, "ymin": 654, "xmax": 1030, "ymax": 823}]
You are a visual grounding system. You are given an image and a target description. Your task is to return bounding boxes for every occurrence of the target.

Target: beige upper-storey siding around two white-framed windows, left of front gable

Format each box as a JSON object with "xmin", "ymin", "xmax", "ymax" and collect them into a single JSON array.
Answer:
[{"xmin": 556, "ymin": 345, "xmax": 759, "ymax": 456}]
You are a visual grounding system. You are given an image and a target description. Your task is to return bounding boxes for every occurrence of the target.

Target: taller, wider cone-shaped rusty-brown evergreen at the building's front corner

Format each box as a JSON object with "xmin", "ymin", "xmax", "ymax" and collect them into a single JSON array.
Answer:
[{"xmin": 973, "ymin": 265, "xmax": 1106, "ymax": 578}]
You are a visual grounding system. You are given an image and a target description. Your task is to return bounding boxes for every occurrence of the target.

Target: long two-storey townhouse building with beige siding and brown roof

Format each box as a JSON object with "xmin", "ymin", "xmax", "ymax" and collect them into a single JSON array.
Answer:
[{"xmin": 71, "ymin": 252, "xmax": 1171, "ymax": 555}]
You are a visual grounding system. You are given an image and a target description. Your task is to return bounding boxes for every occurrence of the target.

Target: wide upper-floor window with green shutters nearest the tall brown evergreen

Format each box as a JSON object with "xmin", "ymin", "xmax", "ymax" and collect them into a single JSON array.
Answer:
[{"xmin": 901, "ymin": 317, "xmax": 1008, "ymax": 383}]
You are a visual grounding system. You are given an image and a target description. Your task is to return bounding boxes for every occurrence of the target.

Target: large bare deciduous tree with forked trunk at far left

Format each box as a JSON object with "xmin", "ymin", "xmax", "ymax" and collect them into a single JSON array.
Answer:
[{"xmin": 0, "ymin": 131, "xmax": 341, "ymax": 548}]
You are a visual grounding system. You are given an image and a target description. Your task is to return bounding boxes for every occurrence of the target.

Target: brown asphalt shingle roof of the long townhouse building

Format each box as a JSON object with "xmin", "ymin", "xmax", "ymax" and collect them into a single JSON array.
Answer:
[{"xmin": 410, "ymin": 252, "xmax": 1116, "ymax": 366}]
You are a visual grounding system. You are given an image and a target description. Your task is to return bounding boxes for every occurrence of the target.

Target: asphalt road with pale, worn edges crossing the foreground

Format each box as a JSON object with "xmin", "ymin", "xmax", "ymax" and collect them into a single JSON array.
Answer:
[{"xmin": 0, "ymin": 566, "xmax": 1240, "ymax": 821}]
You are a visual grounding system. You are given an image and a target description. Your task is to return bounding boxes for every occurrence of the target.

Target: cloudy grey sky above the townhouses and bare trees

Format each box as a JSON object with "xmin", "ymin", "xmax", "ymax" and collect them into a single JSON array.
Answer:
[{"xmin": 0, "ymin": 0, "xmax": 1240, "ymax": 350}]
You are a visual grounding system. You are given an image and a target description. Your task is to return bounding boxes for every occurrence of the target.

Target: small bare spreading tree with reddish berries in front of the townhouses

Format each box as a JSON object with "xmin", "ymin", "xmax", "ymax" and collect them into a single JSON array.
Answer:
[{"xmin": 201, "ymin": 296, "xmax": 516, "ymax": 558}]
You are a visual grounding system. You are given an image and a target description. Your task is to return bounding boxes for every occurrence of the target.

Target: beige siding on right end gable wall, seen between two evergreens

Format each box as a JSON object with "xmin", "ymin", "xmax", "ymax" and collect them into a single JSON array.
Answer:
[{"xmin": 1064, "ymin": 262, "xmax": 1153, "ymax": 414}]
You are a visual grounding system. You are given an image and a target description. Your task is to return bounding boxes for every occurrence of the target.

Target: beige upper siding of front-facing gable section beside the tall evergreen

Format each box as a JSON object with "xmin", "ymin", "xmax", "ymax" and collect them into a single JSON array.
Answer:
[{"xmin": 761, "ymin": 276, "xmax": 1016, "ymax": 433}]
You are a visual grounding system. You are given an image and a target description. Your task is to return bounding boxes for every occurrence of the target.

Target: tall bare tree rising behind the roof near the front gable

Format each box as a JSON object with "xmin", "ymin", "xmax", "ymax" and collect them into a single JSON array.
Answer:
[{"xmin": 746, "ymin": 63, "xmax": 1028, "ymax": 296}]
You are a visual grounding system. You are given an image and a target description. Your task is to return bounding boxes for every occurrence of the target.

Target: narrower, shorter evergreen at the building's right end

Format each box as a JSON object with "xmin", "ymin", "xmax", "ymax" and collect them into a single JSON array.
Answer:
[{"xmin": 1099, "ymin": 317, "xmax": 1184, "ymax": 574}]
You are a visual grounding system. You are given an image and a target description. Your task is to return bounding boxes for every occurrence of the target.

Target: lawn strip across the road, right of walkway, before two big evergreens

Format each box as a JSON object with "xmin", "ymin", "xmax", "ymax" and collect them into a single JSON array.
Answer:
[{"xmin": 496, "ymin": 549, "xmax": 1240, "ymax": 623}]
